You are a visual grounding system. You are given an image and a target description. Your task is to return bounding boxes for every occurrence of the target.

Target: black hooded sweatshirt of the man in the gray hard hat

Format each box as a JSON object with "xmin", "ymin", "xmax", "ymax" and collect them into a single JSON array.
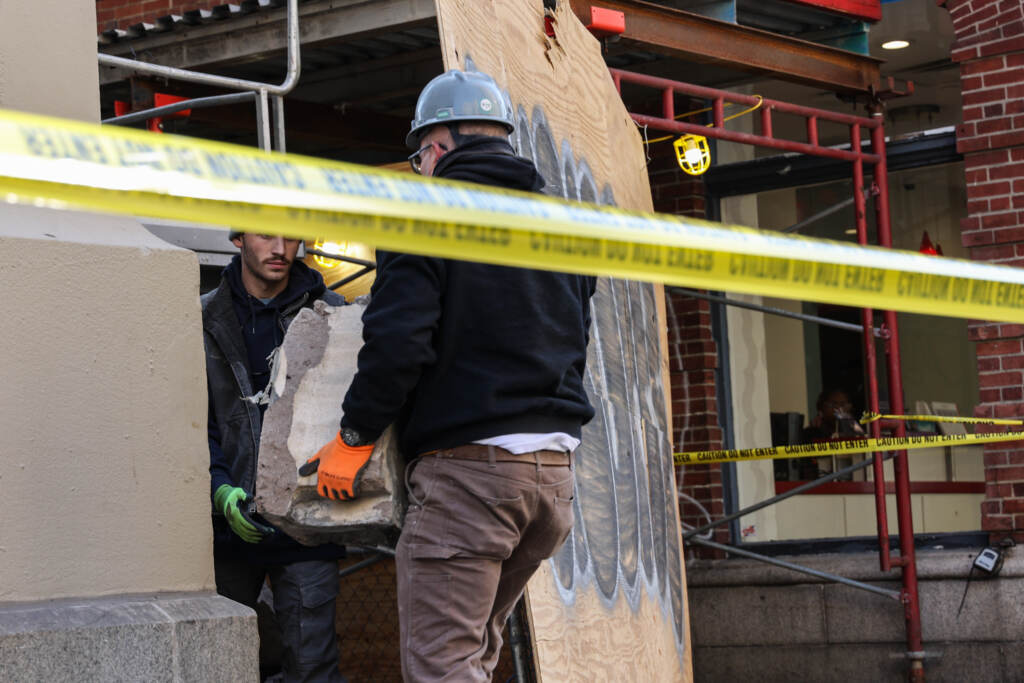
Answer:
[{"xmin": 341, "ymin": 138, "xmax": 595, "ymax": 457}]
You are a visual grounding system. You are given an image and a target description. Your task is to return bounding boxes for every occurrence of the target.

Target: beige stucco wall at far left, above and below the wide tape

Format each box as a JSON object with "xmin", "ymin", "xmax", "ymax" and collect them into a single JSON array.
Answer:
[{"xmin": 0, "ymin": 0, "xmax": 213, "ymax": 603}]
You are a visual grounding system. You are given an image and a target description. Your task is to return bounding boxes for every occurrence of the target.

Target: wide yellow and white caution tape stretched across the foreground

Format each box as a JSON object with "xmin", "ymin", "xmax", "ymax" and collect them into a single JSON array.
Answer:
[{"xmin": 0, "ymin": 112, "xmax": 1024, "ymax": 323}]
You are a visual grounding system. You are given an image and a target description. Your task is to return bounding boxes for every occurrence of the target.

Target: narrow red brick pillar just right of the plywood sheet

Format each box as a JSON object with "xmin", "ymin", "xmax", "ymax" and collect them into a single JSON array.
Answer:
[{"xmin": 648, "ymin": 141, "xmax": 729, "ymax": 557}]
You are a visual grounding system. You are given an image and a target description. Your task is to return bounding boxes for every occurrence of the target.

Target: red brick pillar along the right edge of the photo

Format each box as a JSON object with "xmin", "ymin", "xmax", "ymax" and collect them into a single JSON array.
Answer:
[{"xmin": 945, "ymin": 0, "xmax": 1024, "ymax": 541}]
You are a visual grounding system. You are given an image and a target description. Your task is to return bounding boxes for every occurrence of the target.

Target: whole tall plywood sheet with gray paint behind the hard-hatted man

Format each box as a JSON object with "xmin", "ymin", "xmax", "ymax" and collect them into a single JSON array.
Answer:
[{"xmin": 437, "ymin": 0, "xmax": 692, "ymax": 683}]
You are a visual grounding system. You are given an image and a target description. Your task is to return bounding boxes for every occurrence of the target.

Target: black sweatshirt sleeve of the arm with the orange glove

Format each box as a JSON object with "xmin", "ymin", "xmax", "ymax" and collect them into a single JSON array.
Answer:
[{"xmin": 341, "ymin": 252, "xmax": 445, "ymax": 439}]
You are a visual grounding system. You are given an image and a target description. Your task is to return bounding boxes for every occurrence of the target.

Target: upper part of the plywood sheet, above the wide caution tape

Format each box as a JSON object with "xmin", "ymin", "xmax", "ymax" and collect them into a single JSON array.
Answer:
[{"xmin": 436, "ymin": 0, "xmax": 653, "ymax": 211}]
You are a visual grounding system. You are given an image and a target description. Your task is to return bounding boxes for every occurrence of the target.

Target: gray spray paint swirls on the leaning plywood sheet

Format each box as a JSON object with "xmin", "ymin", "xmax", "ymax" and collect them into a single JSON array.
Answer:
[{"xmin": 512, "ymin": 98, "xmax": 685, "ymax": 661}]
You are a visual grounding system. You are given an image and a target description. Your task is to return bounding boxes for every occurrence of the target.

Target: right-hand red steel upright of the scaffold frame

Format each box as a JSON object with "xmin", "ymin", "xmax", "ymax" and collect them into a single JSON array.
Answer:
[{"xmin": 871, "ymin": 109, "xmax": 925, "ymax": 681}]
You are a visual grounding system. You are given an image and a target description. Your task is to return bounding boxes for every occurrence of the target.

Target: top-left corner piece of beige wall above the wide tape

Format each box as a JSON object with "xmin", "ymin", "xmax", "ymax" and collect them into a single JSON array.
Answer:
[{"xmin": 0, "ymin": 0, "xmax": 99, "ymax": 121}]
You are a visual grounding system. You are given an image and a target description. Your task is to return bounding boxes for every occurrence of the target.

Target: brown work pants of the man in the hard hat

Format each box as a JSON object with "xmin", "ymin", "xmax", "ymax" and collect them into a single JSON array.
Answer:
[{"xmin": 395, "ymin": 449, "xmax": 572, "ymax": 683}]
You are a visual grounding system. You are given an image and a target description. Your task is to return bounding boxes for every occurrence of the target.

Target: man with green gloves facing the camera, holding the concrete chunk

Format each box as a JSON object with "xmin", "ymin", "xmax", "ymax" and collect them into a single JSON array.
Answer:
[{"xmin": 202, "ymin": 232, "xmax": 345, "ymax": 681}]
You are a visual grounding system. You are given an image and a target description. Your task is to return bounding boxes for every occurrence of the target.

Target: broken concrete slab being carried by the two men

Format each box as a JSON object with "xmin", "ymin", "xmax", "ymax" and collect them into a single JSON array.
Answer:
[{"xmin": 255, "ymin": 302, "xmax": 406, "ymax": 545}]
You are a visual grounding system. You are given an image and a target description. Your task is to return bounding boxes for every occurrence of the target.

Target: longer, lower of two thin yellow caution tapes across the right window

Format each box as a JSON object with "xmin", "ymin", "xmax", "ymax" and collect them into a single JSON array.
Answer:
[{"xmin": 675, "ymin": 431, "xmax": 1024, "ymax": 465}]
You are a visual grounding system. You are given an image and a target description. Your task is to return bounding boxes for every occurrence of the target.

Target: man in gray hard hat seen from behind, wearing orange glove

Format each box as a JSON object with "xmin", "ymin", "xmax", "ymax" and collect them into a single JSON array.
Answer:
[{"xmin": 302, "ymin": 71, "xmax": 595, "ymax": 681}]
